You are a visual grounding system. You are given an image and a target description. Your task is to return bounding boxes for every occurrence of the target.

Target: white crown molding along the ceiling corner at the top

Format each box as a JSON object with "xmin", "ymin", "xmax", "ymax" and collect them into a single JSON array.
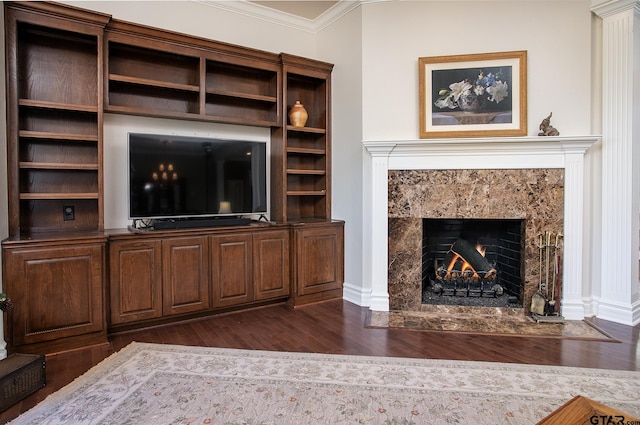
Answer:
[{"xmin": 195, "ymin": 0, "xmax": 361, "ymax": 34}]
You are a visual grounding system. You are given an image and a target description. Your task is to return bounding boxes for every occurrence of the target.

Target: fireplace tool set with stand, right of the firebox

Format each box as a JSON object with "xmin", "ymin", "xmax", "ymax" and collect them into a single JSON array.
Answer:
[{"xmin": 531, "ymin": 232, "xmax": 564, "ymax": 322}]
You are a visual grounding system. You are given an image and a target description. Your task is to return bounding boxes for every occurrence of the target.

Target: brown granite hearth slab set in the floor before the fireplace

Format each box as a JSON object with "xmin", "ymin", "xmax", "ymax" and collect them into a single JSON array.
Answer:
[{"xmin": 365, "ymin": 307, "xmax": 619, "ymax": 342}]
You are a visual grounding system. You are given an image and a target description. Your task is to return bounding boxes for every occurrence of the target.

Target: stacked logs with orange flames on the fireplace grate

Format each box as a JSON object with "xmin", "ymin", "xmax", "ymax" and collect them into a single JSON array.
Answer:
[{"xmin": 433, "ymin": 239, "xmax": 504, "ymax": 297}]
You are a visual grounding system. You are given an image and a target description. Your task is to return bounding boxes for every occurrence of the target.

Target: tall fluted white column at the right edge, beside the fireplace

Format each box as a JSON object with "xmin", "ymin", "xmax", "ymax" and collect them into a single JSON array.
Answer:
[{"xmin": 593, "ymin": 0, "xmax": 640, "ymax": 325}]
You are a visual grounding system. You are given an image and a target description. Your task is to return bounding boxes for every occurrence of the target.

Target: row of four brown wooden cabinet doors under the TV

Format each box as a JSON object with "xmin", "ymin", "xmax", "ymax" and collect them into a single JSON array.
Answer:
[{"xmin": 108, "ymin": 225, "xmax": 291, "ymax": 331}]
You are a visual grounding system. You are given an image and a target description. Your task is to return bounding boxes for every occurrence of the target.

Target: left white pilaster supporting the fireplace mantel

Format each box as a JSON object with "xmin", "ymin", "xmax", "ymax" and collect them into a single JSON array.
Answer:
[{"xmin": 365, "ymin": 143, "xmax": 394, "ymax": 311}]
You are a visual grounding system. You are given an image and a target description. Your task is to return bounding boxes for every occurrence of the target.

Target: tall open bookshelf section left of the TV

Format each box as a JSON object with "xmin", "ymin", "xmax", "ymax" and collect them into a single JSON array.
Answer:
[{"xmin": 7, "ymin": 14, "xmax": 106, "ymax": 235}]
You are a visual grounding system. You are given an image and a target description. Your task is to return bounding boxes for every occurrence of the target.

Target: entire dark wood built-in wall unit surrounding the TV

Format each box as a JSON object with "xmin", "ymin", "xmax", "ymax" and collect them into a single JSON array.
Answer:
[{"xmin": 2, "ymin": 2, "xmax": 344, "ymax": 353}]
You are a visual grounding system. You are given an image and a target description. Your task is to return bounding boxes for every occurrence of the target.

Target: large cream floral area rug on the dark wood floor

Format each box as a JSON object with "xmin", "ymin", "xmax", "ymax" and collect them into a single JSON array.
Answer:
[{"xmin": 12, "ymin": 343, "xmax": 640, "ymax": 425}]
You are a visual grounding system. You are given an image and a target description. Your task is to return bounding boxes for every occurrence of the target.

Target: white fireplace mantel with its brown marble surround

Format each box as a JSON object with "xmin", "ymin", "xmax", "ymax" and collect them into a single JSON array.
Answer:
[{"xmin": 362, "ymin": 136, "xmax": 598, "ymax": 320}]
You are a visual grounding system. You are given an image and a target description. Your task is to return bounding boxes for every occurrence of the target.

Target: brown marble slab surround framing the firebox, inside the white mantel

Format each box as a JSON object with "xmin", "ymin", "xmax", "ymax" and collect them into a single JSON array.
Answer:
[{"xmin": 387, "ymin": 168, "xmax": 564, "ymax": 311}]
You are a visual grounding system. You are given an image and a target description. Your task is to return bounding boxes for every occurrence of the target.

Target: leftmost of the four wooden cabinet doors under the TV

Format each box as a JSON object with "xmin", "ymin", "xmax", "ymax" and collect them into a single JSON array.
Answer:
[{"xmin": 109, "ymin": 241, "xmax": 162, "ymax": 325}]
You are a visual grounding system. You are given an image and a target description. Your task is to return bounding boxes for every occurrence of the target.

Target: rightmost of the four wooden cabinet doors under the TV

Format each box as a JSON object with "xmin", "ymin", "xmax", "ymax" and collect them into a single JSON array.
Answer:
[{"xmin": 253, "ymin": 230, "xmax": 290, "ymax": 300}]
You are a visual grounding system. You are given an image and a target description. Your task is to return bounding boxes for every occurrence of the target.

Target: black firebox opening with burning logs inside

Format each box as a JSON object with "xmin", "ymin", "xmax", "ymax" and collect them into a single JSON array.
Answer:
[{"xmin": 422, "ymin": 218, "xmax": 525, "ymax": 307}]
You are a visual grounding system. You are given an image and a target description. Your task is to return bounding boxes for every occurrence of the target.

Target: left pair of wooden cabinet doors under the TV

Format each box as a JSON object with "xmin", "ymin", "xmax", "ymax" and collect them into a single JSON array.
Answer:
[{"xmin": 109, "ymin": 233, "xmax": 211, "ymax": 329}]
